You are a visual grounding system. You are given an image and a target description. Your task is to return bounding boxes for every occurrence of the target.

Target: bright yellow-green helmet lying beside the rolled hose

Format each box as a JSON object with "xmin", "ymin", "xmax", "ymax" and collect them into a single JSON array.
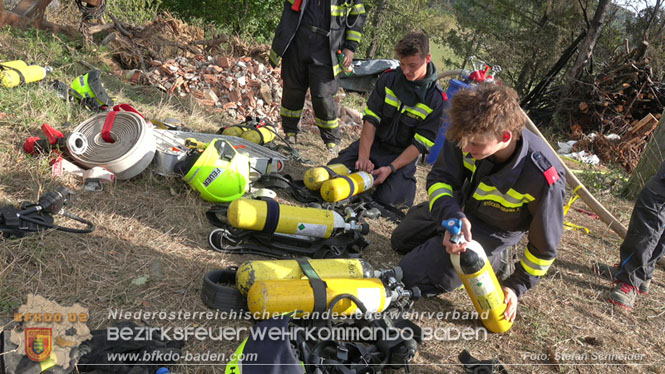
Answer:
[{"xmin": 183, "ymin": 139, "xmax": 249, "ymax": 203}]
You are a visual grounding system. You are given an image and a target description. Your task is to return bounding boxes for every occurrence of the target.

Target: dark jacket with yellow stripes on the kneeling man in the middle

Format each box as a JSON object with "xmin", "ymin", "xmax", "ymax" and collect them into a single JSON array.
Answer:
[{"xmin": 363, "ymin": 68, "xmax": 445, "ymax": 154}]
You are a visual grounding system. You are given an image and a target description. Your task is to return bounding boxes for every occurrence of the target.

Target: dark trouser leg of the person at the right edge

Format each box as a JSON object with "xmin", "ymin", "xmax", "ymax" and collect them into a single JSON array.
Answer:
[{"xmin": 616, "ymin": 176, "xmax": 665, "ymax": 287}]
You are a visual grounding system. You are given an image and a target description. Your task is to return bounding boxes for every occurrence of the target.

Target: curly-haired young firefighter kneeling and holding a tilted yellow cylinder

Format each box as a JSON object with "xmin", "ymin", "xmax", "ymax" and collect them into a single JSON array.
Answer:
[{"xmin": 392, "ymin": 84, "xmax": 566, "ymax": 321}]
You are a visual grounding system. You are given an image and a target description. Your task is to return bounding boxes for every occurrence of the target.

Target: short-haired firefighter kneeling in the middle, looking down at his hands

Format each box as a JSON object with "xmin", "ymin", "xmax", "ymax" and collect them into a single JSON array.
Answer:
[{"xmin": 329, "ymin": 32, "xmax": 445, "ymax": 206}]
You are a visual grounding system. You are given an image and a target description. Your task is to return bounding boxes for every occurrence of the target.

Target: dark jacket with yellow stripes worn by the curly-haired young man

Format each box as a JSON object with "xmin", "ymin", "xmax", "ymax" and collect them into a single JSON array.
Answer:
[{"xmin": 427, "ymin": 129, "xmax": 566, "ymax": 297}]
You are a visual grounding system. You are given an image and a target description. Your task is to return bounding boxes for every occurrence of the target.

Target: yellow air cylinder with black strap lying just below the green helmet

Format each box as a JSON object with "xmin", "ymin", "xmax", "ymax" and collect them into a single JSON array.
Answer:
[{"xmin": 227, "ymin": 199, "xmax": 345, "ymax": 238}]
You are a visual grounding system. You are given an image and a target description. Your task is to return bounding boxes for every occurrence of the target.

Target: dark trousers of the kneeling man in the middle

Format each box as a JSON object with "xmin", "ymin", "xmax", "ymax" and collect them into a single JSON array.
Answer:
[{"xmin": 328, "ymin": 140, "xmax": 416, "ymax": 206}]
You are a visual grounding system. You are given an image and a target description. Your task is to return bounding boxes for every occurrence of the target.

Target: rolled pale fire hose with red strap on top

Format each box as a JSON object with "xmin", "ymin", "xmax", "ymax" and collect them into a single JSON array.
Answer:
[{"xmin": 71, "ymin": 112, "xmax": 155, "ymax": 180}]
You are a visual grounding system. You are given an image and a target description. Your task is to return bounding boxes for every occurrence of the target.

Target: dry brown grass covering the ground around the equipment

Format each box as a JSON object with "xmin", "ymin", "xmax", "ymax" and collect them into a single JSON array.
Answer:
[{"xmin": 0, "ymin": 21, "xmax": 665, "ymax": 373}]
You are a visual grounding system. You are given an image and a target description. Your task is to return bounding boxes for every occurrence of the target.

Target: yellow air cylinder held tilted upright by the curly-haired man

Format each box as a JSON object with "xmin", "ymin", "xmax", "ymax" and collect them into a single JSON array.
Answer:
[{"xmin": 450, "ymin": 240, "xmax": 513, "ymax": 333}]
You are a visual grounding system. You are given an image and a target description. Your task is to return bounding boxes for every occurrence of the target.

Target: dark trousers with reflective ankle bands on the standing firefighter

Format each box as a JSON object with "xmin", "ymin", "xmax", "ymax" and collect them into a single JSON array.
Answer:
[{"xmin": 280, "ymin": 26, "xmax": 341, "ymax": 144}]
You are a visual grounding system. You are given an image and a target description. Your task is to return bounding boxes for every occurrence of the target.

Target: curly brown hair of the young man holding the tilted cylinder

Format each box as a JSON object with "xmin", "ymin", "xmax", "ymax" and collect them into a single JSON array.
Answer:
[{"xmin": 446, "ymin": 84, "xmax": 525, "ymax": 147}]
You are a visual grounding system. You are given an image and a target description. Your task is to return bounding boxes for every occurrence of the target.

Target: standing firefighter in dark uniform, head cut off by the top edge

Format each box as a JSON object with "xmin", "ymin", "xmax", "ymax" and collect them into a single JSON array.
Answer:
[{"xmin": 270, "ymin": 0, "xmax": 366, "ymax": 153}]
